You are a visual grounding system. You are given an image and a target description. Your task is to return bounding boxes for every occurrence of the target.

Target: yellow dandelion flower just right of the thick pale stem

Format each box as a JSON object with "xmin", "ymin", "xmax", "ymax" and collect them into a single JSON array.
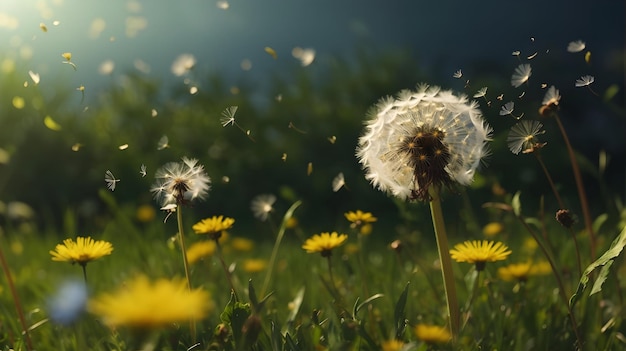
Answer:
[{"xmin": 450, "ymin": 240, "xmax": 511, "ymax": 271}]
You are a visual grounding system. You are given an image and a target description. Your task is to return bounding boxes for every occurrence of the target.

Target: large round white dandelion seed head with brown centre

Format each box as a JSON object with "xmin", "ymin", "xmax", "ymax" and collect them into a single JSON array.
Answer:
[{"xmin": 356, "ymin": 85, "xmax": 492, "ymax": 201}]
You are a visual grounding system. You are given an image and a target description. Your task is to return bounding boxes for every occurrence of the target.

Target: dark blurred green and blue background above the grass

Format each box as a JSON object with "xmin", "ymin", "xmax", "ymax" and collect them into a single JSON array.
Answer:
[{"xmin": 0, "ymin": 0, "xmax": 626, "ymax": 236}]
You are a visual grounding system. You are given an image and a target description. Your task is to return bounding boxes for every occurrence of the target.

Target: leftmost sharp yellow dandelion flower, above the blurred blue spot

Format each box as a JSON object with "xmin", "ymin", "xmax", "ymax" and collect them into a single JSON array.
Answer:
[{"xmin": 50, "ymin": 236, "xmax": 113, "ymax": 265}]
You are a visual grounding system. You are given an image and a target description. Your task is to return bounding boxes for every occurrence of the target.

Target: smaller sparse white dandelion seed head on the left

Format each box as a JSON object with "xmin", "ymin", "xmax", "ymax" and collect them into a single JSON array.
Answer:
[{"xmin": 150, "ymin": 157, "xmax": 211, "ymax": 207}]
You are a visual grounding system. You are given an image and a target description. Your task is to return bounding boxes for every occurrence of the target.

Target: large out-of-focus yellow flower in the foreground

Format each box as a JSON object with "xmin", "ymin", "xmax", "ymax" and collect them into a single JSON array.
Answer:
[{"xmin": 87, "ymin": 276, "xmax": 213, "ymax": 329}]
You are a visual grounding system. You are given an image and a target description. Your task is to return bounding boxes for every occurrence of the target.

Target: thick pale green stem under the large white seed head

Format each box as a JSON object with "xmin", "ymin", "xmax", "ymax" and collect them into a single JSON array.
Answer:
[{"xmin": 429, "ymin": 187, "xmax": 460, "ymax": 338}]
